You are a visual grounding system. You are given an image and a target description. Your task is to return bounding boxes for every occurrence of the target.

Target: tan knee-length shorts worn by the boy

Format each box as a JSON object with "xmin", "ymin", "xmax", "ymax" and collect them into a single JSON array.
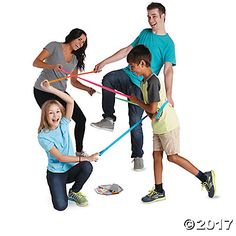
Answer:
[{"xmin": 153, "ymin": 128, "xmax": 180, "ymax": 155}]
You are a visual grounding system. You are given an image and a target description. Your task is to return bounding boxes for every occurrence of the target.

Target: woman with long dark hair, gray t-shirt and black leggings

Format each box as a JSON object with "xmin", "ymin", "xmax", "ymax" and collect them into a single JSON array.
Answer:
[{"xmin": 33, "ymin": 28, "xmax": 95, "ymax": 156}]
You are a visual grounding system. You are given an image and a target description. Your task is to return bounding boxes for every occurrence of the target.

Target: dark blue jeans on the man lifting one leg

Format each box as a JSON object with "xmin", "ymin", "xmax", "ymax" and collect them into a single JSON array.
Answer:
[{"xmin": 102, "ymin": 69, "xmax": 143, "ymax": 157}]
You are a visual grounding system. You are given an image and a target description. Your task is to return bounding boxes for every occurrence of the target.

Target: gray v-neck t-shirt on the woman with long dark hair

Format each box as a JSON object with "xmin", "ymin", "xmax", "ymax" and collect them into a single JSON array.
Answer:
[{"xmin": 34, "ymin": 42, "xmax": 78, "ymax": 91}]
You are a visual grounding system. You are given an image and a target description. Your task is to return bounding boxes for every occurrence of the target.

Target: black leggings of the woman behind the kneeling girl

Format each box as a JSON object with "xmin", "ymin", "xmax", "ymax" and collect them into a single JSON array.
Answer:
[{"xmin": 34, "ymin": 88, "xmax": 86, "ymax": 152}]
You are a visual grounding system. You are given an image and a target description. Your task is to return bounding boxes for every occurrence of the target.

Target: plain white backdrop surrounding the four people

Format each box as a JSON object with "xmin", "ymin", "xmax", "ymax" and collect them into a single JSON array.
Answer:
[{"xmin": 0, "ymin": 0, "xmax": 236, "ymax": 236}]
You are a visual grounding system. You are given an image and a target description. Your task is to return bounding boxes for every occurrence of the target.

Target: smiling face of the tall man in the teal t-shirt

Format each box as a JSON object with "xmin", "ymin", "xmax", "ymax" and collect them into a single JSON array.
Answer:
[{"xmin": 147, "ymin": 8, "xmax": 165, "ymax": 32}]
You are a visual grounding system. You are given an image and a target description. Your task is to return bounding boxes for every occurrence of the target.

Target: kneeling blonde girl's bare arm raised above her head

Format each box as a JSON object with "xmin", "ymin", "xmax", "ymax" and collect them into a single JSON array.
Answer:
[{"xmin": 41, "ymin": 80, "xmax": 74, "ymax": 120}]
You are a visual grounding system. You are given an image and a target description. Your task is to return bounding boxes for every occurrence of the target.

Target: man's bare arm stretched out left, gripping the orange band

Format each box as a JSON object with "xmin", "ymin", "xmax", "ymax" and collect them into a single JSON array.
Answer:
[{"xmin": 94, "ymin": 45, "xmax": 133, "ymax": 72}]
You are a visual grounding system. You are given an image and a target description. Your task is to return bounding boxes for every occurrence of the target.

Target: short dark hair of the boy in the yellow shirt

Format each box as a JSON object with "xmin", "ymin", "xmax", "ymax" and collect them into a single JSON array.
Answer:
[{"xmin": 127, "ymin": 44, "xmax": 152, "ymax": 66}]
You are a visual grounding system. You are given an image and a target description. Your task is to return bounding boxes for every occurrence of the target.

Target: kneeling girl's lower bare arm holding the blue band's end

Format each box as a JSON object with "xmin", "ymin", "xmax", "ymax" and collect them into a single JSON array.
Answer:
[{"xmin": 49, "ymin": 146, "xmax": 98, "ymax": 162}]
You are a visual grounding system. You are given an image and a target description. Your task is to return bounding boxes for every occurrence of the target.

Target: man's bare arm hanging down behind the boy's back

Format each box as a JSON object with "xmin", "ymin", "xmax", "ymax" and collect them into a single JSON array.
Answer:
[{"xmin": 163, "ymin": 62, "xmax": 174, "ymax": 106}]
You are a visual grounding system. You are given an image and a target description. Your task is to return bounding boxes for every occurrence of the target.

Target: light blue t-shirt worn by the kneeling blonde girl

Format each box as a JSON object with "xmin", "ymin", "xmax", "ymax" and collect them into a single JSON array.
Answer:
[{"xmin": 38, "ymin": 117, "xmax": 76, "ymax": 173}]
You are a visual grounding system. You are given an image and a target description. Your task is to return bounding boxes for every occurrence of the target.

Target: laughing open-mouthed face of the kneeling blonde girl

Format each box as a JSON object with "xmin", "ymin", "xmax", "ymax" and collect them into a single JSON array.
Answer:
[{"xmin": 46, "ymin": 104, "xmax": 62, "ymax": 129}]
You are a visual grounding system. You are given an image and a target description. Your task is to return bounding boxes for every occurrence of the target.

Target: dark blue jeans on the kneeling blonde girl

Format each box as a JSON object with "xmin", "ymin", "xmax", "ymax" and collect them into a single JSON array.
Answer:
[{"xmin": 47, "ymin": 161, "xmax": 93, "ymax": 211}]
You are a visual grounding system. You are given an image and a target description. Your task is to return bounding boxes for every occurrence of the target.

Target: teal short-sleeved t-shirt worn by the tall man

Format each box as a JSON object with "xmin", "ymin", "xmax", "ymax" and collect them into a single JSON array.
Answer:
[{"xmin": 123, "ymin": 29, "xmax": 176, "ymax": 87}]
